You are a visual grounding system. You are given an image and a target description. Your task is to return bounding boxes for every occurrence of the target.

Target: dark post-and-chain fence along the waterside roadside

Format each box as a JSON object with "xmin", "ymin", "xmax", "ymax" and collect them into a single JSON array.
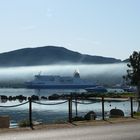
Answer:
[{"xmin": 0, "ymin": 97, "xmax": 136, "ymax": 129}]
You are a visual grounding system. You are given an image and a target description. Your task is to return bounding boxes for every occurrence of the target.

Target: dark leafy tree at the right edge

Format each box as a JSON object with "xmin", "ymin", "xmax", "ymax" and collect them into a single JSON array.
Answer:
[{"xmin": 124, "ymin": 51, "xmax": 140, "ymax": 112}]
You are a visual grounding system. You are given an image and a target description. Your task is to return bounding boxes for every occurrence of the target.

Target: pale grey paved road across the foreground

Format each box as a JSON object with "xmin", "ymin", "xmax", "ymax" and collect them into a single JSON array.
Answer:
[{"xmin": 0, "ymin": 122, "xmax": 140, "ymax": 140}]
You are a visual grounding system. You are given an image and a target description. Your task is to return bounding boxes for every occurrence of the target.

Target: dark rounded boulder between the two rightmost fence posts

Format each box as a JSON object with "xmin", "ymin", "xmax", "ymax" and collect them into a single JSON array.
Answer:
[{"xmin": 110, "ymin": 109, "xmax": 124, "ymax": 118}]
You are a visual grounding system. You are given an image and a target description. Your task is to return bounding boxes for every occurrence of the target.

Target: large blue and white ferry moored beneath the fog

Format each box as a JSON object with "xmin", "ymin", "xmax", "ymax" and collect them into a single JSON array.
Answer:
[{"xmin": 25, "ymin": 71, "xmax": 97, "ymax": 89}]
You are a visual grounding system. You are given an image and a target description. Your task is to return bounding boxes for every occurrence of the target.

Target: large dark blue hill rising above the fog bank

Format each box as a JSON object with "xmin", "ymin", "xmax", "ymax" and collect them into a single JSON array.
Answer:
[{"xmin": 0, "ymin": 46, "xmax": 121, "ymax": 67}]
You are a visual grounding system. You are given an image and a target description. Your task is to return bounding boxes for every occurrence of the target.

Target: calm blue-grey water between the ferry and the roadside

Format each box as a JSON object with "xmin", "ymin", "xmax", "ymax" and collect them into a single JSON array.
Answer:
[{"xmin": 0, "ymin": 88, "xmax": 137, "ymax": 127}]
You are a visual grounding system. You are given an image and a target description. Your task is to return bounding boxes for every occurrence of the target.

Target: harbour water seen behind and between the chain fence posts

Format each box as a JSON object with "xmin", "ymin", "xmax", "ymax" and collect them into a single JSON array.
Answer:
[{"xmin": 0, "ymin": 89, "xmax": 138, "ymax": 127}]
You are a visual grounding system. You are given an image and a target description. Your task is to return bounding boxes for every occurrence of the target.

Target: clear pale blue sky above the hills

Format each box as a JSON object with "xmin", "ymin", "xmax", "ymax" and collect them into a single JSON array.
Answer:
[{"xmin": 0, "ymin": 0, "xmax": 140, "ymax": 60}]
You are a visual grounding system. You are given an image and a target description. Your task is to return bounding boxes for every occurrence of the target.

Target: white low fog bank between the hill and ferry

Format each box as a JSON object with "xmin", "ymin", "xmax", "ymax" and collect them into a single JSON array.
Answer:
[{"xmin": 0, "ymin": 63, "xmax": 128, "ymax": 85}]
